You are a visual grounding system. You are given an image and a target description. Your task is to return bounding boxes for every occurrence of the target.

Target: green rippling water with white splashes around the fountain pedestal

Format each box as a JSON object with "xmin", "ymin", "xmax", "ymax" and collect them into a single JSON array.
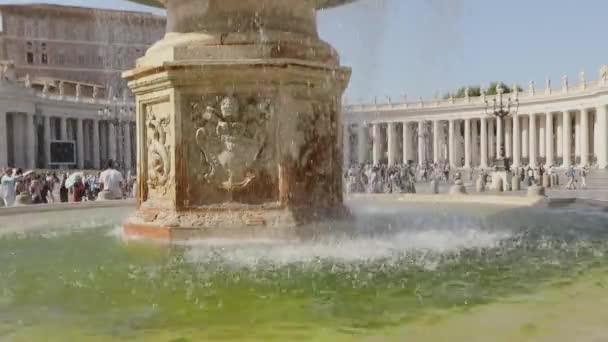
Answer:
[{"xmin": 0, "ymin": 207, "xmax": 608, "ymax": 341}]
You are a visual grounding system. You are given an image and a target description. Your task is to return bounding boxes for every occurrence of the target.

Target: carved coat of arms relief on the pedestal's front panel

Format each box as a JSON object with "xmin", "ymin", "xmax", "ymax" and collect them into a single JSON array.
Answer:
[{"xmin": 191, "ymin": 95, "xmax": 272, "ymax": 193}]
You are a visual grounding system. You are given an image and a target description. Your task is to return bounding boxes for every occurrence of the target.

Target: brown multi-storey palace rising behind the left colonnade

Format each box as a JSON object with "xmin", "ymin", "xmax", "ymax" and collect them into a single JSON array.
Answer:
[{"xmin": 0, "ymin": 4, "xmax": 166, "ymax": 97}]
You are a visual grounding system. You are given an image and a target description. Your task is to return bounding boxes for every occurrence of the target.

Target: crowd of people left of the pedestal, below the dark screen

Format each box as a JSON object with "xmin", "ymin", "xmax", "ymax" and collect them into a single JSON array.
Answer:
[{"xmin": 0, "ymin": 161, "xmax": 137, "ymax": 207}]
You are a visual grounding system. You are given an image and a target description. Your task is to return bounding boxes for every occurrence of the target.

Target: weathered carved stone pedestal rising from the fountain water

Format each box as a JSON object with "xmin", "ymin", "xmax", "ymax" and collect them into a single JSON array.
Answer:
[{"xmin": 124, "ymin": 0, "xmax": 350, "ymax": 239}]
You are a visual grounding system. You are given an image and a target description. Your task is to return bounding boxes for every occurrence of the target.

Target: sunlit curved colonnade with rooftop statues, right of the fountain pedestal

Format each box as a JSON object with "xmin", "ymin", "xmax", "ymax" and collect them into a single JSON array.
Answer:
[{"xmin": 344, "ymin": 66, "xmax": 608, "ymax": 169}]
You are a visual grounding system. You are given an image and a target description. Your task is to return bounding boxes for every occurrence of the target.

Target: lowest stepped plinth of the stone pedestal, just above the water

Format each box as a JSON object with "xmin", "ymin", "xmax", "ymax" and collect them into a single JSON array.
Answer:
[{"xmin": 124, "ymin": 207, "xmax": 351, "ymax": 242}]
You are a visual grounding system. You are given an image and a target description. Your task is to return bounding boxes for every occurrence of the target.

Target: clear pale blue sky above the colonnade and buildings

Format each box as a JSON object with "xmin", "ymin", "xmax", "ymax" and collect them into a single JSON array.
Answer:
[{"xmin": 0, "ymin": 0, "xmax": 608, "ymax": 102}]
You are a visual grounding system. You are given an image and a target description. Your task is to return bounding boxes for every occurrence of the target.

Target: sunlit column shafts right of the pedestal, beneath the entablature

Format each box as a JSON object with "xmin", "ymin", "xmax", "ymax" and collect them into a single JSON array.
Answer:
[{"xmin": 345, "ymin": 105, "xmax": 608, "ymax": 169}]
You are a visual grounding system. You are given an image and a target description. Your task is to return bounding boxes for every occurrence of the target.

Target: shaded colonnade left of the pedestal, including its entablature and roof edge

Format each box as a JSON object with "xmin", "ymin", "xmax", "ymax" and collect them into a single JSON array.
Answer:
[{"xmin": 0, "ymin": 68, "xmax": 136, "ymax": 171}]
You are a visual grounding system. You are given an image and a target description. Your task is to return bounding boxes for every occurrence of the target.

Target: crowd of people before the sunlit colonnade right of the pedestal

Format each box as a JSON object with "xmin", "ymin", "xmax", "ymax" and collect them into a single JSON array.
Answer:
[{"xmin": 344, "ymin": 162, "xmax": 589, "ymax": 193}]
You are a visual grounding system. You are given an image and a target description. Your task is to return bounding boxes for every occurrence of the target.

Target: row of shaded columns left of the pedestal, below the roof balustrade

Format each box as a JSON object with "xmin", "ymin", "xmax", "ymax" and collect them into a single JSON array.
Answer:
[{"xmin": 0, "ymin": 112, "xmax": 136, "ymax": 170}]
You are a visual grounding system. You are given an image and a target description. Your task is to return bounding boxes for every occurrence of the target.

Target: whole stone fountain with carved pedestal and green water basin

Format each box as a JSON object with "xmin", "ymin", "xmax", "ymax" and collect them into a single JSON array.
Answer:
[{"xmin": 0, "ymin": 0, "xmax": 608, "ymax": 341}]
